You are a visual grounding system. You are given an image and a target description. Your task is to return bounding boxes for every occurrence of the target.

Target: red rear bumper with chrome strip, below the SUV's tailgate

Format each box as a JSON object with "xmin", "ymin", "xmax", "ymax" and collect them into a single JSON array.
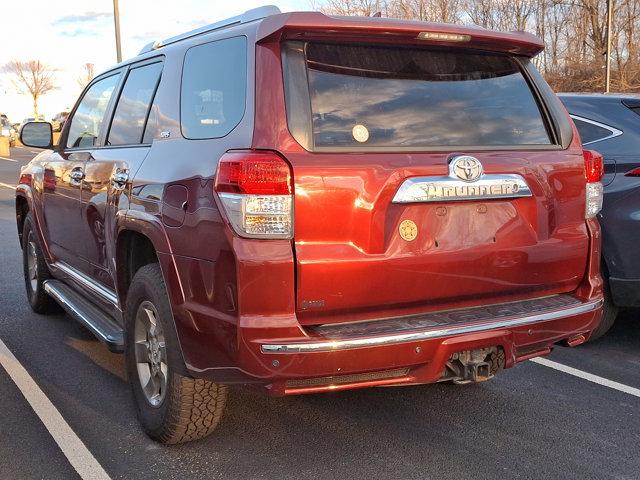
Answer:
[{"xmin": 225, "ymin": 295, "xmax": 603, "ymax": 395}]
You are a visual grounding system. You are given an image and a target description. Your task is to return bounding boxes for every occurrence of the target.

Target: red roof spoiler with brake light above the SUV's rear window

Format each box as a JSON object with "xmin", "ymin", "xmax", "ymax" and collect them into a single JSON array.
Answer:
[{"xmin": 258, "ymin": 12, "xmax": 544, "ymax": 57}]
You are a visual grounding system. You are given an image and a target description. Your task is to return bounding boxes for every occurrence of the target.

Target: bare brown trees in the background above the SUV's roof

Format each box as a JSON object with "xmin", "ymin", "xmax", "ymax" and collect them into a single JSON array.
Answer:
[{"xmin": 314, "ymin": 0, "xmax": 640, "ymax": 92}]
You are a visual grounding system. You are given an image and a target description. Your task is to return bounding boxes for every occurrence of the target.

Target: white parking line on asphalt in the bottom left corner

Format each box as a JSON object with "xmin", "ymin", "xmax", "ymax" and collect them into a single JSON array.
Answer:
[{"xmin": 0, "ymin": 340, "xmax": 109, "ymax": 480}]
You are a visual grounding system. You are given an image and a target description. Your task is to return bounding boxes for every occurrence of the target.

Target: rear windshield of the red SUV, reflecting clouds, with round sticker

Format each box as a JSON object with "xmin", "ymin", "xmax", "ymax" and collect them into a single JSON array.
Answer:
[{"xmin": 288, "ymin": 43, "xmax": 551, "ymax": 148}]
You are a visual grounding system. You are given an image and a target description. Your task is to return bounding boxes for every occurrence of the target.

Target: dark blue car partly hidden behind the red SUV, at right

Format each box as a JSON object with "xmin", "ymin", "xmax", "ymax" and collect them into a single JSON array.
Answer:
[{"xmin": 560, "ymin": 94, "xmax": 640, "ymax": 338}]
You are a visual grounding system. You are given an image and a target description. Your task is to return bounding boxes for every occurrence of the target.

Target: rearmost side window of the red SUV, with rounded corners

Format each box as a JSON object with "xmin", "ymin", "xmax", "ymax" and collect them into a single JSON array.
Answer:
[{"xmin": 180, "ymin": 37, "xmax": 247, "ymax": 138}]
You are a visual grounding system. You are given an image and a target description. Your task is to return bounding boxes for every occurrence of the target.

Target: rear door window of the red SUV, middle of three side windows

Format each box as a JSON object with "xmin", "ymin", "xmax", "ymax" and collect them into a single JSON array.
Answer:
[{"xmin": 107, "ymin": 63, "xmax": 162, "ymax": 145}]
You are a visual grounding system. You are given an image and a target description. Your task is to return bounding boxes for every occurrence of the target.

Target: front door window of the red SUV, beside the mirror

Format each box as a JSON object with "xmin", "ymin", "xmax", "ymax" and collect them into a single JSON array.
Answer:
[{"xmin": 67, "ymin": 75, "xmax": 120, "ymax": 148}]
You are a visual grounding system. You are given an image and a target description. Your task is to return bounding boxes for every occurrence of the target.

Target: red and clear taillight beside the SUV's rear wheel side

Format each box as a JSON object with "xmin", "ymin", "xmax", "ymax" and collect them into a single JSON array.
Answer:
[{"xmin": 214, "ymin": 150, "xmax": 293, "ymax": 238}]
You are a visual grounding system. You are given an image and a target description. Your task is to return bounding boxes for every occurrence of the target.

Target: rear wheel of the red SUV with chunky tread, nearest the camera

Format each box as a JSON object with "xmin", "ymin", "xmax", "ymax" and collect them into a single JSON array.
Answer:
[{"xmin": 125, "ymin": 263, "xmax": 227, "ymax": 444}]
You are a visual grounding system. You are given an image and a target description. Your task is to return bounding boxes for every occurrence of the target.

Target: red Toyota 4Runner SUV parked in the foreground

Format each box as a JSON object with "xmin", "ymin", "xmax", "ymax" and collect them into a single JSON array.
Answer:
[{"xmin": 16, "ymin": 7, "xmax": 602, "ymax": 443}]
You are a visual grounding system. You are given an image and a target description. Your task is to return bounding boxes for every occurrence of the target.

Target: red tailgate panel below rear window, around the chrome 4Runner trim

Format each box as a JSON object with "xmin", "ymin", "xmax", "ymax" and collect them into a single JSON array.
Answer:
[{"xmin": 289, "ymin": 152, "xmax": 589, "ymax": 323}]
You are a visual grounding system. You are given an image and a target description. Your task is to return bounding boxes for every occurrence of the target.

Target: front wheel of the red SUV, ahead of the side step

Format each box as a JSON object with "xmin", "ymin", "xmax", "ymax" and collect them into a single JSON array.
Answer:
[{"xmin": 22, "ymin": 212, "xmax": 61, "ymax": 314}]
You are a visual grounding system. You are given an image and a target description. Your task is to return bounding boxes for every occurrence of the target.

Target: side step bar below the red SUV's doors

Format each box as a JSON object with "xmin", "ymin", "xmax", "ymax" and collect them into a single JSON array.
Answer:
[{"xmin": 44, "ymin": 280, "xmax": 124, "ymax": 353}]
